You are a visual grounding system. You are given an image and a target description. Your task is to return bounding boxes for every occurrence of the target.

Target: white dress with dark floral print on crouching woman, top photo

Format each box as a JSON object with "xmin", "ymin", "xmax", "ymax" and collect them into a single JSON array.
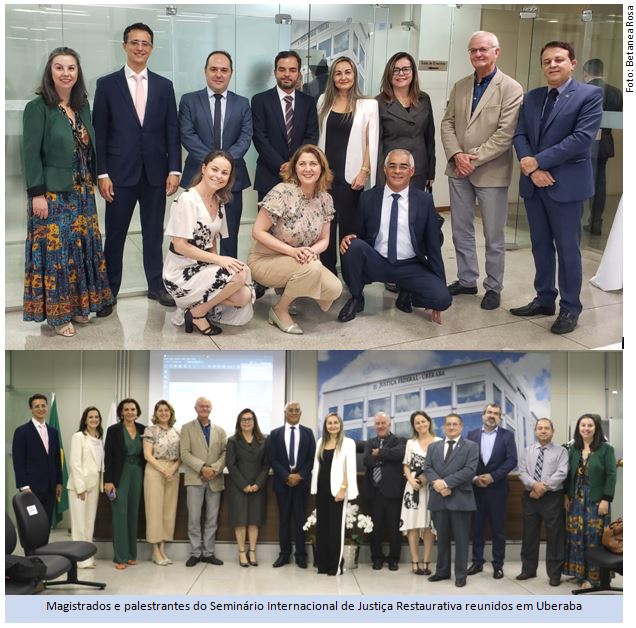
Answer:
[{"xmin": 163, "ymin": 188, "xmax": 254, "ymax": 325}]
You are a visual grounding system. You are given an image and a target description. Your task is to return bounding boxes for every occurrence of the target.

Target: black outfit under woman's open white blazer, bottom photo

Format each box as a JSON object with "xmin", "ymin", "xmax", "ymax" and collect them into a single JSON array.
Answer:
[{"xmin": 316, "ymin": 449, "xmax": 344, "ymax": 576}]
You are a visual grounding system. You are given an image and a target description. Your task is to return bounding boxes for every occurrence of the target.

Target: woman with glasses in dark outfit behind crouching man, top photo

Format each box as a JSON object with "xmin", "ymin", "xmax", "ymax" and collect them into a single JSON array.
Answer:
[{"xmin": 376, "ymin": 52, "xmax": 435, "ymax": 190}]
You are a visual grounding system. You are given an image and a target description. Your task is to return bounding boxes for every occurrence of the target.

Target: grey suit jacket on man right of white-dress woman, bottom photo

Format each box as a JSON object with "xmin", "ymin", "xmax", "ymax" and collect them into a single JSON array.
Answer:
[{"xmin": 424, "ymin": 438, "xmax": 479, "ymax": 511}]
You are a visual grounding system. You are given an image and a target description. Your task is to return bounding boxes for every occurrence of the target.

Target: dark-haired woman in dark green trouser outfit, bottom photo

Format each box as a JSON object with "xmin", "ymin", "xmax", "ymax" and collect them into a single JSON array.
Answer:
[{"xmin": 104, "ymin": 399, "xmax": 146, "ymax": 569}]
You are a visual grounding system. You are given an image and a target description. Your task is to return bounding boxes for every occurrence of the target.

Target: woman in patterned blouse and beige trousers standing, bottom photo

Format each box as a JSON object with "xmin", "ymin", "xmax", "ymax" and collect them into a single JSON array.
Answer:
[{"xmin": 143, "ymin": 399, "xmax": 181, "ymax": 566}]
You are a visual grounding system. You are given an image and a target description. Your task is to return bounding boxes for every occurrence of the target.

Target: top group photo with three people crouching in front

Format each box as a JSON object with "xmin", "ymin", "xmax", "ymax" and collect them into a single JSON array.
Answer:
[{"xmin": 4, "ymin": 3, "xmax": 624, "ymax": 351}]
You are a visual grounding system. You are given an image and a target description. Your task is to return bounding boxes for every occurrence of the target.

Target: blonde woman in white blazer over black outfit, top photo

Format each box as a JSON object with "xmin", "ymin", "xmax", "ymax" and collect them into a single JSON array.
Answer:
[{"xmin": 317, "ymin": 57, "xmax": 380, "ymax": 274}]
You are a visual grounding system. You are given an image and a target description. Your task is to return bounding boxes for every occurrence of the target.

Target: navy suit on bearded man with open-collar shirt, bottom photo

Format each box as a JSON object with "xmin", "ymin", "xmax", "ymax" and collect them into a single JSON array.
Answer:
[{"xmin": 468, "ymin": 427, "xmax": 517, "ymax": 569}]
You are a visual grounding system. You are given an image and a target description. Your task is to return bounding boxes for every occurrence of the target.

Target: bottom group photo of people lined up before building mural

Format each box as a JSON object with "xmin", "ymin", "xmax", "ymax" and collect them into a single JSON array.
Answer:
[{"xmin": 5, "ymin": 351, "xmax": 623, "ymax": 597}]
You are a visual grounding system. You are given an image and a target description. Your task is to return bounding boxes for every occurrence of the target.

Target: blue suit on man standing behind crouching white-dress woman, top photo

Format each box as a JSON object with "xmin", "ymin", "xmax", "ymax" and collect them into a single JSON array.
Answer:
[{"xmin": 179, "ymin": 88, "xmax": 252, "ymax": 257}]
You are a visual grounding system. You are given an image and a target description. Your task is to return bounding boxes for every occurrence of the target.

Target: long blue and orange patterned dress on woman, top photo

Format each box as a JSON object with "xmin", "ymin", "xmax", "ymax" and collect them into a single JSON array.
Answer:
[{"xmin": 23, "ymin": 107, "xmax": 114, "ymax": 326}]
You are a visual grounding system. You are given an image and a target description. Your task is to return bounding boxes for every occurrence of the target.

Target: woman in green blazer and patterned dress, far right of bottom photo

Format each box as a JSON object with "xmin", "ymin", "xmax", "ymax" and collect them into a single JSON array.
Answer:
[{"xmin": 563, "ymin": 414, "xmax": 616, "ymax": 588}]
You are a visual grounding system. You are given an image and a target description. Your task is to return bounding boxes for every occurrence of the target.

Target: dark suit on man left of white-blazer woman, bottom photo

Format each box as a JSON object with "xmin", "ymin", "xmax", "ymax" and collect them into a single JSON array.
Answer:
[{"xmin": 265, "ymin": 424, "xmax": 316, "ymax": 560}]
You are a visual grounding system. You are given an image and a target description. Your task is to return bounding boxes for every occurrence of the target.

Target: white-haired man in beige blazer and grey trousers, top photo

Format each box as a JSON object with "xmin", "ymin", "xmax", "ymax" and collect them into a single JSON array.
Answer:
[{"xmin": 441, "ymin": 31, "xmax": 523, "ymax": 310}]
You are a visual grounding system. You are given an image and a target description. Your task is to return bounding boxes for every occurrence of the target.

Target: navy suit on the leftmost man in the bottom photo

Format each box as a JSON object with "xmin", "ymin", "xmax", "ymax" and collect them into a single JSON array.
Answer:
[{"xmin": 12, "ymin": 421, "xmax": 62, "ymax": 522}]
